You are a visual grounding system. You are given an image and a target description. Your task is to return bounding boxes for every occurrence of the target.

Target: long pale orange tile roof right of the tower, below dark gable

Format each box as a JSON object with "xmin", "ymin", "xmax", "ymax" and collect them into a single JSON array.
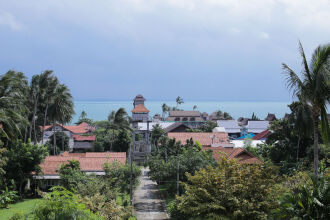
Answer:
[{"xmin": 168, "ymin": 132, "xmax": 229, "ymax": 146}]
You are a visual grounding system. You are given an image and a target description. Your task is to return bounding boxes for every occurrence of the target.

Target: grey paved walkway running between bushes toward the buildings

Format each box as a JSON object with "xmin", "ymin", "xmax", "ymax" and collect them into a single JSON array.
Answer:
[{"xmin": 133, "ymin": 168, "xmax": 168, "ymax": 220}]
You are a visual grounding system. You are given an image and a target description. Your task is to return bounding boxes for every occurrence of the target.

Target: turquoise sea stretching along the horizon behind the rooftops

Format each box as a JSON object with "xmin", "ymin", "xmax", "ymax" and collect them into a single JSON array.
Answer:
[{"xmin": 72, "ymin": 100, "xmax": 290, "ymax": 123}]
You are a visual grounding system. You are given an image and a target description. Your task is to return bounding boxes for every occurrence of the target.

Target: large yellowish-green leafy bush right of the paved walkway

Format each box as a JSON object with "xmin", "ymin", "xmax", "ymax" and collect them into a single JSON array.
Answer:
[{"xmin": 177, "ymin": 157, "xmax": 277, "ymax": 219}]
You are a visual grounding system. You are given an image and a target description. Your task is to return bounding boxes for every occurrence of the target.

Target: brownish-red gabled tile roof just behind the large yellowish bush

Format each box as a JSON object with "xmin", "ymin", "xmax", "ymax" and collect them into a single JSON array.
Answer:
[{"xmin": 203, "ymin": 147, "xmax": 262, "ymax": 164}]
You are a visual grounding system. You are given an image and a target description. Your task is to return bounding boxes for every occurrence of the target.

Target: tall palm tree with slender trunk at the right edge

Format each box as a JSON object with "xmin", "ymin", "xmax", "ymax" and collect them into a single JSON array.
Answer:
[{"xmin": 282, "ymin": 42, "xmax": 330, "ymax": 177}]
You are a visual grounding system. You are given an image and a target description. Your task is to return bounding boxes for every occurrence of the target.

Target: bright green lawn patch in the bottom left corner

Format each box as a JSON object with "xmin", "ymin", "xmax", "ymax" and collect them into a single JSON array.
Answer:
[{"xmin": 0, "ymin": 199, "xmax": 41, "ymax": 220}]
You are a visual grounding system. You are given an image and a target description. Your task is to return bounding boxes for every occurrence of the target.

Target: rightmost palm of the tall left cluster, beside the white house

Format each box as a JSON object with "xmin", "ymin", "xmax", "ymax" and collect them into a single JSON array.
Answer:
[{"xmin": 49, "ymin": 84, "xmax": 74, "ymax": 155}]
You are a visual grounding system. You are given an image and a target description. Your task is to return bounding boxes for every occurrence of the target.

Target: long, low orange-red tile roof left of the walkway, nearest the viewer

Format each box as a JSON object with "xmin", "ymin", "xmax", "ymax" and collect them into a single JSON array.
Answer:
[{"xmin": 40, "ymin": 152, "xmax": 126, "ymax": 175}]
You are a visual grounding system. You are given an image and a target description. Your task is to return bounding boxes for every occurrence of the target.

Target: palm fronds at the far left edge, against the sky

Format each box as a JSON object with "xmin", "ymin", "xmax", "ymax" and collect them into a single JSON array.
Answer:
[{"xmin": 0, "ymin": 70, "xmax": 28, "ymax": 143}]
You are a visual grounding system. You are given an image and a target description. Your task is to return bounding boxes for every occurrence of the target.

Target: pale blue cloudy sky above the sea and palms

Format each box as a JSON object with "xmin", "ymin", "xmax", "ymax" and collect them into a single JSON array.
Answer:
[{"xmin": 0, "ymin": 0, "xmax": 330, "ymax": 101}]
